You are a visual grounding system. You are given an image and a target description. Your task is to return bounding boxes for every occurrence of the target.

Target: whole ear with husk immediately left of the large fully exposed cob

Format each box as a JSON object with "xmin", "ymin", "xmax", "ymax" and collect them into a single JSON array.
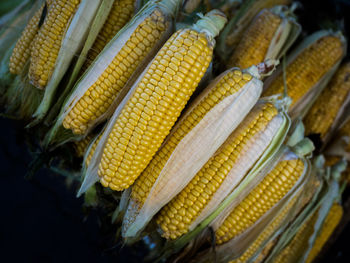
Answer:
[{"xmin": 47, "ymin": 0, "xmax": 179, "ymax": 146}]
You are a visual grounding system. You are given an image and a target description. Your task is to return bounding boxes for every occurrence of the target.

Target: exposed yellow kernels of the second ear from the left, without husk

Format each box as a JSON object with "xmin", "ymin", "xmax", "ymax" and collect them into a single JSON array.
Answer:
[{"xmin": 29, "ymin": 0, "xmax": 80, "ymax": 89}]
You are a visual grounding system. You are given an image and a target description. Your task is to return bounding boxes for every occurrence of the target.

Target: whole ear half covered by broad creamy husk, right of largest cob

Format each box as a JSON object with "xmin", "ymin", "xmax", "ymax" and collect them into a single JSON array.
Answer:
[{"xmin": 123, "ymin": 64, "xmax": 278, "ymax": 239}]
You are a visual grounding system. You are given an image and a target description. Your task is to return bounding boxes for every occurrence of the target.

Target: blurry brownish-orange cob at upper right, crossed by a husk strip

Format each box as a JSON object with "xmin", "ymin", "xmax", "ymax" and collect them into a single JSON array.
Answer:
[{"xmin": 263, "ymin": 35, "xmax": 343, "ymax": 106}]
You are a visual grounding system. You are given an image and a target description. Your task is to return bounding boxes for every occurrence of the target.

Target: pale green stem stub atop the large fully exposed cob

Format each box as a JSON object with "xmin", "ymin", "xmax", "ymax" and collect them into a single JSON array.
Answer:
[{"xmin": 193, "ymin": 9, "xmax": 227, "ymax": 38}]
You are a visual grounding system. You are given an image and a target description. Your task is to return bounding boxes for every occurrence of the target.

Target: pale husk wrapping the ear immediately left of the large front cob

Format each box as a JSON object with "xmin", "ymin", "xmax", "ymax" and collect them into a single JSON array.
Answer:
[{"xmin": 44, "ymin": 0, "xmax": 178, "ymax": 147}]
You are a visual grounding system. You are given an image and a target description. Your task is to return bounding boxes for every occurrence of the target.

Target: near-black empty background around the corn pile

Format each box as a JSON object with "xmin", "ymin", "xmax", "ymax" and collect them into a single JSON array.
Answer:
[{"xmin": 0, "ymin": 0, "xmax": 350, "ymax": 262}]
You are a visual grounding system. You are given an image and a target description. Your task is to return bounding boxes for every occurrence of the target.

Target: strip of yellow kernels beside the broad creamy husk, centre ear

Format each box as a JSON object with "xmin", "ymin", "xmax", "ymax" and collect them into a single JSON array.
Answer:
[{"xmin": 131, "ymin": 70, "xmax": 252, "ymax": 212}]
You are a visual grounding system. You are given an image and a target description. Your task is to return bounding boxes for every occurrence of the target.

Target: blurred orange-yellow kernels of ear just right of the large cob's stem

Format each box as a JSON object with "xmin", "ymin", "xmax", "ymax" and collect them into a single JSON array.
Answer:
[{"xmin": 228, "ymin": 9, "xmax": 282, "ymax": 69}]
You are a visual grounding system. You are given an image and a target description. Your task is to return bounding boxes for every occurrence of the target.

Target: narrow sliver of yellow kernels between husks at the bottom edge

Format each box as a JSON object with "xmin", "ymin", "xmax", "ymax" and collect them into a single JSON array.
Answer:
[{"xmin": 230, "ymin": 194, "xmax": 300, "ymax": 263}]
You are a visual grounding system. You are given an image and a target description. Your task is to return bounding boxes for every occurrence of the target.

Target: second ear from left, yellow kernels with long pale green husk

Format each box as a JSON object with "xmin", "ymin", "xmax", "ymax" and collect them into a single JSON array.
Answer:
[{"xmin": 28, "ymin": 0, "xmax": 117, "ymax": 126}]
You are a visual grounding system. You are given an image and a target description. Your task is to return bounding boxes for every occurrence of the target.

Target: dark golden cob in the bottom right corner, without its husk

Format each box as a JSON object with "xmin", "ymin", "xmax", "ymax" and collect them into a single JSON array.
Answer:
[{"xmin": 306, "ymin": 203, "xmax": 344, "ymax": 263}]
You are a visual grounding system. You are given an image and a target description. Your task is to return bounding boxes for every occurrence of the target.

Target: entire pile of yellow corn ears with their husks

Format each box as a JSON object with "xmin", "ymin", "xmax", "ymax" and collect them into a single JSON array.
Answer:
[{"xmin": 0, "ymin": 0, "xmax": 350, "ymax": 262}]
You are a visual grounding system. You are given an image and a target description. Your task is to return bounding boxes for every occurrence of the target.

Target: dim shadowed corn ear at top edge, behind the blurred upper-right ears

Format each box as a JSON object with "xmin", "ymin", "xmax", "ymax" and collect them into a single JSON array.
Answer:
[{"xmin": 217, "ymin": 0, "xmax": 291, "ymax": 61}]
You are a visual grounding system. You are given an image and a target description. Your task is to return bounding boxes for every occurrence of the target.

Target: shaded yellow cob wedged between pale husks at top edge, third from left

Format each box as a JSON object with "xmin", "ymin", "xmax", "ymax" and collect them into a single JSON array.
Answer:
[{"xmin": 82, "ymin": 0, "xmax": 135, "ymax": 72}]
